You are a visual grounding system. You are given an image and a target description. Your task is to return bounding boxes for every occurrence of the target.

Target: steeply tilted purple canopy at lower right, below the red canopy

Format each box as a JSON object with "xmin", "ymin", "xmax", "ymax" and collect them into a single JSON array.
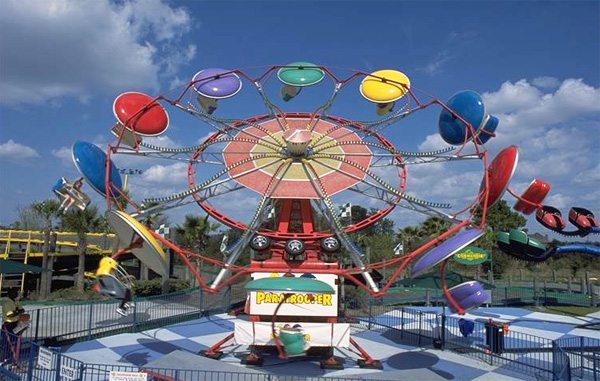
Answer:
[{"xmin": 411, "ymin": 228, "xmax": 483, "ymax": 278}]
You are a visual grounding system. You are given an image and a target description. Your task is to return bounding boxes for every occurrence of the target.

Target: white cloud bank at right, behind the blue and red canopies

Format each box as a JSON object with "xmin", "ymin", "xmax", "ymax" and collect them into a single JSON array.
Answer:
[{"xmin": 413, "ymin": 78, "xmax": 600, "ymax": 230}]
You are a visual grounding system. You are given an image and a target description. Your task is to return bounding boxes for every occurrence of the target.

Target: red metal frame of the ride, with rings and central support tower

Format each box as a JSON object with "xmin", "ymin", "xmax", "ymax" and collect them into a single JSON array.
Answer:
[{"xmin": 98, "ymin": 65, "xmax": 502, "ymax": 365}]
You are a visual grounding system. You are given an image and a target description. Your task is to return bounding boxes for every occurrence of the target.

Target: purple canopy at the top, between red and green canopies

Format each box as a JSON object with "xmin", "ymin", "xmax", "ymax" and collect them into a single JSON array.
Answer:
[{"xmin": 192, "ymin": 68, "xmax": 242, "ymax": 99}]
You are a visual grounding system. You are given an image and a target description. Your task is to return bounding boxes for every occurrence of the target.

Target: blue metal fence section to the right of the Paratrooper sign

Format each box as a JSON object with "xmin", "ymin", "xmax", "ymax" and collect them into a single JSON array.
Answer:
[{"xmin": 348, "ymin": 304, "xmax": 600, "ymax": 381}]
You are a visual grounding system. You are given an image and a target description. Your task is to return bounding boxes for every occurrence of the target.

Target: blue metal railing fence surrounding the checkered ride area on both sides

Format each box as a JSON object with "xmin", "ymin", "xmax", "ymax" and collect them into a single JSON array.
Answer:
[{"xmin": 0, "ymin": 285, "xmax": 600, "ymax": 381}]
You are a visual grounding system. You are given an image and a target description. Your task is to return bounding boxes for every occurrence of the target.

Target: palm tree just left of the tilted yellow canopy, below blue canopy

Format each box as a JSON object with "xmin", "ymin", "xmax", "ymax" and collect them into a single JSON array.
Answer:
[{"xmin": 61, "ymin": 206, "xmax": 104, "ymax": 291}]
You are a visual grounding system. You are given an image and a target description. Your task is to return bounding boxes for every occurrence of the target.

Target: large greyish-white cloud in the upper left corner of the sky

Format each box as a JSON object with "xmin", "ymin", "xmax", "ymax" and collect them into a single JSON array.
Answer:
[{"xmin": 0, "ymin": 0, "xmax": 196, "ymax": 106}]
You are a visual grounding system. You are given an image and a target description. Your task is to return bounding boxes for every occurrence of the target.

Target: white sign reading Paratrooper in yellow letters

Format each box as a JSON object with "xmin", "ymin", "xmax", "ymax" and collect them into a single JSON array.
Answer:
[{"xmin": 250, "ymin": 273, "xmax": 338, "ymax": 316}]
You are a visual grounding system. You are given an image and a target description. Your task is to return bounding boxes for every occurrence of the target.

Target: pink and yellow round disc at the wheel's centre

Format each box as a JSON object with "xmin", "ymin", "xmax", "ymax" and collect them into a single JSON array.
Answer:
[{"xmin": 223, "ymin": 114, "xmax": 372, "ymax": 199}]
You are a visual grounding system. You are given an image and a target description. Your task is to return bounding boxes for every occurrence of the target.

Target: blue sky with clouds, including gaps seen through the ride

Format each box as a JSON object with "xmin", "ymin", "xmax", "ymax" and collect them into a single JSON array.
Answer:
[{"xmin": 0, "ymin": 0, "xmax": 600, "ymax": 238}]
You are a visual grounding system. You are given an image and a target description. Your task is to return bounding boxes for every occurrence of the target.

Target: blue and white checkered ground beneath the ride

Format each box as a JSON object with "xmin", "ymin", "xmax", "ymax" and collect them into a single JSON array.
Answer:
[{"xmin": 63, "ymin": 308, "xmax": 600, "ymax": 380}]
